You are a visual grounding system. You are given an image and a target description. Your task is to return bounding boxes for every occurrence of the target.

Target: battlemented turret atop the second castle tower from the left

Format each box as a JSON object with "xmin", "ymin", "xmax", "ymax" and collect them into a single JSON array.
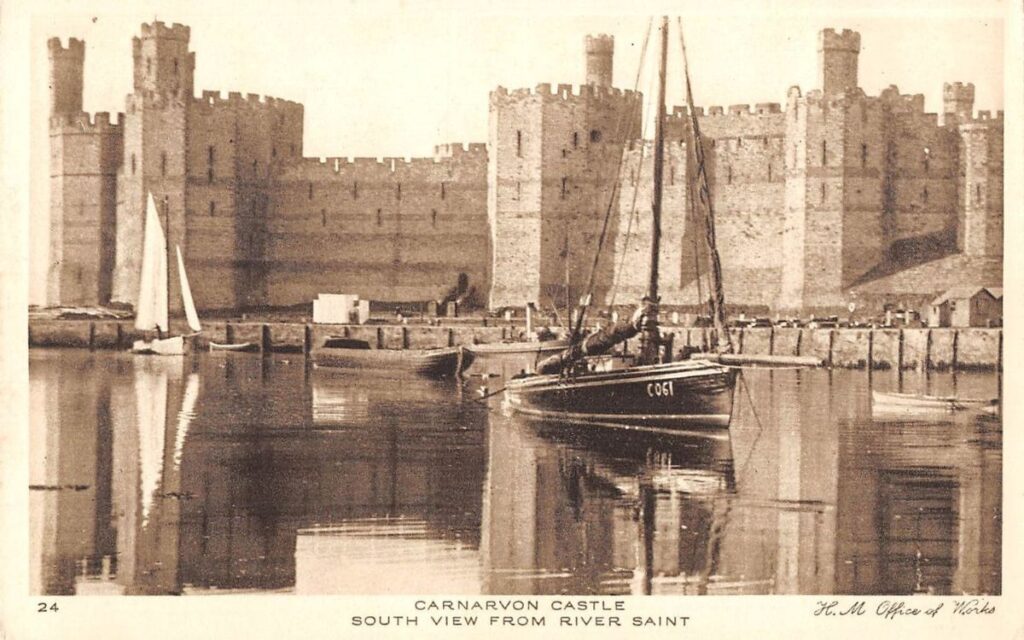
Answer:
[{"xmin": 132, "ymin": 22, "xmax": 196, "ymax": 96}]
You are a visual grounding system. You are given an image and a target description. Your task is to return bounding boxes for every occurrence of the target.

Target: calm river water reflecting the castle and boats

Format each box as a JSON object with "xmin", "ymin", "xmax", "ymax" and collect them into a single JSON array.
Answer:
[{"xmin": 30, "ymin": 350, "xmax": 1002, "ymax": 595}]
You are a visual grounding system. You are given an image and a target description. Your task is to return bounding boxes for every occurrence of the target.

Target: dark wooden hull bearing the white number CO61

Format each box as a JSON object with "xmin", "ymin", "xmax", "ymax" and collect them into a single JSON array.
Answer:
[{"xmin": 506, "ymin": 360, "xmax": 736, "ymax": 432}]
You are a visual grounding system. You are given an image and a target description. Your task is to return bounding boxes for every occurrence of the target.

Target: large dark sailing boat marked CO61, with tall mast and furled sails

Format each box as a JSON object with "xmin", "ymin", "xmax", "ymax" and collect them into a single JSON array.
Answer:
[{"xmin": 506, "ymin": 17, "xmax": 736, "ymax": 430}]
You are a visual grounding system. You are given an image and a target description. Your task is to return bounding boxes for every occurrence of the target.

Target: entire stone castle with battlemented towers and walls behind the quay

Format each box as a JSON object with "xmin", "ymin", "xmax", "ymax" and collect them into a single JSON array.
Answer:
[{"xmin": 47, "ymin": 22, "xmax": 1002, "ymax": 312}]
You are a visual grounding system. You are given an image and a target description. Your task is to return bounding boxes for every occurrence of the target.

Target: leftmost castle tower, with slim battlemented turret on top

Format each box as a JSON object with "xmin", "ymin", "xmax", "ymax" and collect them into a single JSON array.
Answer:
[{"xmin": 46, "ymin": 38, "xmax": 123, "ymax": 305}]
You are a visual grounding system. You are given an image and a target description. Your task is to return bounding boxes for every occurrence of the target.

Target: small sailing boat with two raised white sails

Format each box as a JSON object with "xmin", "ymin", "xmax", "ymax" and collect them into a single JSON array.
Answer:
[{"xmin": 131, "ymin": 194, "xmax": 202, "ymax": 355}]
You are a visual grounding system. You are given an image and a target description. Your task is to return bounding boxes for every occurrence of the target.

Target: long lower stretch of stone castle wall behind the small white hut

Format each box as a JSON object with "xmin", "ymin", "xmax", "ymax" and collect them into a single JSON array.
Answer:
[{"xmin": 264, "ymin": 144, "xmax": 489, "ymax": 305}]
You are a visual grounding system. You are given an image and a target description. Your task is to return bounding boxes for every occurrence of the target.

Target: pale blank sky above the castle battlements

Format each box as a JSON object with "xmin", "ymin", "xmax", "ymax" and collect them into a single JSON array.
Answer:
[{"xmin": 29, "ymin": 0, "xmax": 1005, "ymax": 303}]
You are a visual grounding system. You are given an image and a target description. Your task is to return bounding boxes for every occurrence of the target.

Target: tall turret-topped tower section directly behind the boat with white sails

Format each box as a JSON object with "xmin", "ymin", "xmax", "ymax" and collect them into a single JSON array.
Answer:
[{"xmin": 113, "ymin": 22, "xmax": 196, "ymax": 312}]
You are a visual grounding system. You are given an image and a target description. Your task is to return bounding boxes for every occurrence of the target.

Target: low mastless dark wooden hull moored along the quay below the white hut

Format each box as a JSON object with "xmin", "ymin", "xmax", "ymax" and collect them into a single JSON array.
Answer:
[{"xmin": 310, "ymin": 347, "xmax": 459, "ymax": 378}]
